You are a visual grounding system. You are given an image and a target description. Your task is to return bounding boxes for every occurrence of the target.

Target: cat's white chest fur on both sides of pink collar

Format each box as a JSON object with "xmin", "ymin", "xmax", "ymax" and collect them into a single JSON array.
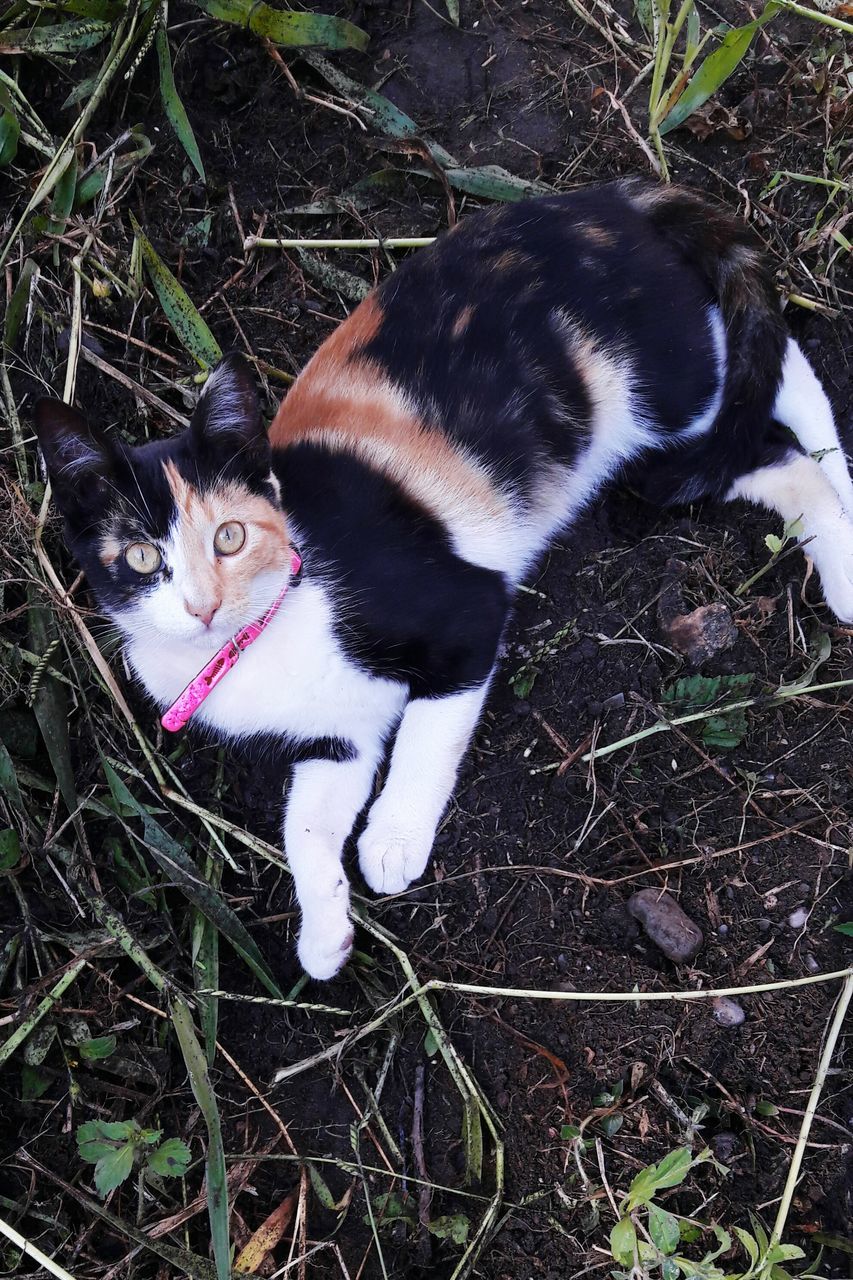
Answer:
[{"xmin": 127, "ymin": 581, "xmax": 406, "ymax": 746}]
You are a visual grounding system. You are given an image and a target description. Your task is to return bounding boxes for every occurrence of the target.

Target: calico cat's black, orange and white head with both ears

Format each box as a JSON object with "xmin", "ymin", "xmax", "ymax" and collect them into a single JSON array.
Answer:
[{"xmin": 35, "ymin": 356, "xmax": 291, "ymax": 650}]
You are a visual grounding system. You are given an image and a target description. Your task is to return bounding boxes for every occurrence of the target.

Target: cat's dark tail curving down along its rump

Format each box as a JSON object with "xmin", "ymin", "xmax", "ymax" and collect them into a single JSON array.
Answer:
[{"xmin": 626, "ymin": 183, "xmax": 788, "ymax": 504}]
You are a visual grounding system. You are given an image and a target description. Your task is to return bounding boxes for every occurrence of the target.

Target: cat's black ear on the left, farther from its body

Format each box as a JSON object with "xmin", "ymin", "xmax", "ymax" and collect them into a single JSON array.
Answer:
[{"xmin": 33, "ymin": 399, "xmax": 115, "ymax": 516}]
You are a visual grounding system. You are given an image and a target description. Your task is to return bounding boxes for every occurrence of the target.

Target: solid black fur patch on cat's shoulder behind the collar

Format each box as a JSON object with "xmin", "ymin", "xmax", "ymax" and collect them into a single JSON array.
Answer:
[{"xmin": 273, "ymin": 444, "xmax": 510, "ymax": 698}]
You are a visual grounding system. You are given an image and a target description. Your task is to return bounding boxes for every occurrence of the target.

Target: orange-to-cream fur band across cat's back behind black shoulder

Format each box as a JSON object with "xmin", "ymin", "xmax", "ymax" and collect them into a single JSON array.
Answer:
[{"xmin": 269, "ymin": 294, "xmax": 506, "ymax": 521}]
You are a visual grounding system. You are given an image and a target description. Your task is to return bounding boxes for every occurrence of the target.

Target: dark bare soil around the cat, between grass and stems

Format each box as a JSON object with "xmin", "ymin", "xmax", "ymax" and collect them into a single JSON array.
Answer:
[{"xmin": 0, "ymin": 0, "xmax": 853, "ymax": 1280}]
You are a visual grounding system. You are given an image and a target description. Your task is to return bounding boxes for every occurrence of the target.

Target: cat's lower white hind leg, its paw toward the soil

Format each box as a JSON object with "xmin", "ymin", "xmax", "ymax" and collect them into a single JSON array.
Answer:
[{"xmin": 725, "ymin": 448, "xmax": 853, "ymax": 622}]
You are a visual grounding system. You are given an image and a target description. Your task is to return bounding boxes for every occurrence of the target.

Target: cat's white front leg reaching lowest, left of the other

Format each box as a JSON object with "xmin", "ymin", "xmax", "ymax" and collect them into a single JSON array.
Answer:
[{"xmin": 284, "ymin": 751, "xmax": 379, "ymax": 978}]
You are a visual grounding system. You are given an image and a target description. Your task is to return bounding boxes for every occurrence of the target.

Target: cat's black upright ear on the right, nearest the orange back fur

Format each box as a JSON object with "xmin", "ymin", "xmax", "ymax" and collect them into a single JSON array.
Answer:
[{"xmin": 190, "ymin": 352, "xmax": 270, "ymax": 468}]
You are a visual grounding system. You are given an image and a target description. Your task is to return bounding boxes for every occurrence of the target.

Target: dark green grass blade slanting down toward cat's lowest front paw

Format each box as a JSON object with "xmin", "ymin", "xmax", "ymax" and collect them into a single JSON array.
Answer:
[{"xmin": 104, "ymin": 760, "xmax": 284, "ymax": 1000}]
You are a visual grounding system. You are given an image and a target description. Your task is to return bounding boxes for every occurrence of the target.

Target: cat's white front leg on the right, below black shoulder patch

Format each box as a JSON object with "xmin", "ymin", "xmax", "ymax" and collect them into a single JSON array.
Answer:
[{"xmin": 359, "ymin": 680, "xmax": 489, "ymax": 893}]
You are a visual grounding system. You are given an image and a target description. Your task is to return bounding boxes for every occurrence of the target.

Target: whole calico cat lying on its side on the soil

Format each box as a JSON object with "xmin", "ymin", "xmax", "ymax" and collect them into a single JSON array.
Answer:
[{"xmin": 36, "ymin": 182, "xmax": 853, "ymax": 978}]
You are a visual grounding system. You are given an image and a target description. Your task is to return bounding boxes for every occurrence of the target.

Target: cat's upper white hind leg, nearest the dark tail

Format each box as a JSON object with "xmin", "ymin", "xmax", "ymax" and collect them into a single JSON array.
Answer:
[{"xmin": 774, "ymin": 338, "xmax": 853, "ymax": 518}]
